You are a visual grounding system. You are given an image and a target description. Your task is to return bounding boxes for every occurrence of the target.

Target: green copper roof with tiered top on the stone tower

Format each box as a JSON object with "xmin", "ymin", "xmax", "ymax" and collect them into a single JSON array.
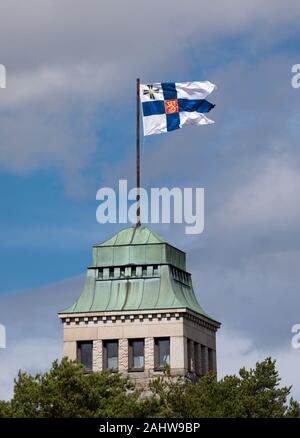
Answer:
[{"xmin": 60, "ymin": 226, "xmax": 211, "ymax": 316}]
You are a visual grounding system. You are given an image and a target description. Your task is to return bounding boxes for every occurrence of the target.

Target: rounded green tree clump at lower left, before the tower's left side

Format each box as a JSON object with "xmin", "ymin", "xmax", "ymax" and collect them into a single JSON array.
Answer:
[{"xmin": 11, "ymin": 359, "xmax": 139, "ymax": 418}]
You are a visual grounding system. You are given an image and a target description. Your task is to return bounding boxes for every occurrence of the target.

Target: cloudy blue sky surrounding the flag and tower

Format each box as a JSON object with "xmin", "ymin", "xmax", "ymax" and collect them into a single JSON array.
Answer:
[{"xmin": 0, "ymin": 0, "xmax": 300, "ymax": 398}]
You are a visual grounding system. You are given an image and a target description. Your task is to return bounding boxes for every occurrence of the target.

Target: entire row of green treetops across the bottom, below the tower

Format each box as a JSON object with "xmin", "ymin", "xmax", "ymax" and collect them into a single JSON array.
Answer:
[{"xmin": 0, "ymin": 358, "xmax": 300, "ymax": 418}]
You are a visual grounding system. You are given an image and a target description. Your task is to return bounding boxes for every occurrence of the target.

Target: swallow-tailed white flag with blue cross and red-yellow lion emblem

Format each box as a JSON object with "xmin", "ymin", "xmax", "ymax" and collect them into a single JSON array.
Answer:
[{"xmin": 140, "ymin": 81, "xmax": 216, "ymax": 135}]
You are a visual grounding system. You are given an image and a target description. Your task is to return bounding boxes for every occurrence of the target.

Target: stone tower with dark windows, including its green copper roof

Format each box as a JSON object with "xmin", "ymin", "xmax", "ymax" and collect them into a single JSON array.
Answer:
[{"xmin": 59, "ymin": 226, "xmax": 220, "ymax": 385}]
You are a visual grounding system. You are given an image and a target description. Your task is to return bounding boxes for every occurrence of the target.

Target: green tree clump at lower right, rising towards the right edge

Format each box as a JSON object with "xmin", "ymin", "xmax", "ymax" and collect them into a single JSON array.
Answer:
[{"xmin": 151, "ymin": 358, "xmax": 300, "ymax": 418}]
